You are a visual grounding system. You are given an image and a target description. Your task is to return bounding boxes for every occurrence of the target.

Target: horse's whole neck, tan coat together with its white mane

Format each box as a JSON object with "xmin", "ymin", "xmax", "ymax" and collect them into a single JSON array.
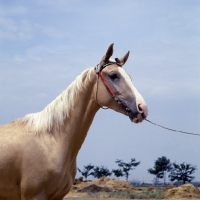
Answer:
[{"xmin": 23, "ymin": 69, "xmax": 99, "ymax": 160}]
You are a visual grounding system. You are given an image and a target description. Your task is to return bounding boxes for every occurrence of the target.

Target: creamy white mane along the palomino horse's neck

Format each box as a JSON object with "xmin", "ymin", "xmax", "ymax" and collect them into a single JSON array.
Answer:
[{"xmin": 23, "ymin": 69, "xmax": 92, "ymax": 132}]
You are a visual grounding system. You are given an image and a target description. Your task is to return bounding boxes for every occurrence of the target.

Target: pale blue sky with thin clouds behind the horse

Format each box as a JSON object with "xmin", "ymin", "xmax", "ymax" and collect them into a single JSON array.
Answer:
[{"xmin": 0, "ymin": 0, "xmax": 200, "ymax": 181}]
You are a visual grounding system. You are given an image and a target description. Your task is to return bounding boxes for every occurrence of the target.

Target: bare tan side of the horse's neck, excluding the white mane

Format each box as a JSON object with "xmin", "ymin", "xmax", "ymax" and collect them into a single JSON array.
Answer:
[{"xmin": 54, "ymin": 69, "xmax": 99, "ymax": 157}]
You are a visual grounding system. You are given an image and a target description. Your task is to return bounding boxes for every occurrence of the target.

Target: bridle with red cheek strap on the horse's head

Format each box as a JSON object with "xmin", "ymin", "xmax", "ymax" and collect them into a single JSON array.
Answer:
[{"xmin": 95, "ymin": 58, "xmax": 130, "ymax": 114}]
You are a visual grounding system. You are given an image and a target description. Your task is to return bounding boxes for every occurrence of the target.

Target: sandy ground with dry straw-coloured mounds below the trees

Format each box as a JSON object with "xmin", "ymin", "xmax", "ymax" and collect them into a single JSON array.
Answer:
[{"xmin": 65, "ymin": 177, "xmax": 200, "ymax": 200}]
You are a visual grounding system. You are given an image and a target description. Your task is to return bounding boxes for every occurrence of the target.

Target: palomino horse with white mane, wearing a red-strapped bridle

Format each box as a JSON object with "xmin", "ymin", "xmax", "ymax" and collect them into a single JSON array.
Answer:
[{"xmin": 0, "ymin": 44, "xmax": 148, "ymax": 200}]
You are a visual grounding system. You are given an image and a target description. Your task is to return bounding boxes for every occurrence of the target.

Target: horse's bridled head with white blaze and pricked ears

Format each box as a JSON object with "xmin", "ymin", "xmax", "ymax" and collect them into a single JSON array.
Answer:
[{"xmin": 95, "ymin": 44, "xmax": 148, "ymax": 123}]
